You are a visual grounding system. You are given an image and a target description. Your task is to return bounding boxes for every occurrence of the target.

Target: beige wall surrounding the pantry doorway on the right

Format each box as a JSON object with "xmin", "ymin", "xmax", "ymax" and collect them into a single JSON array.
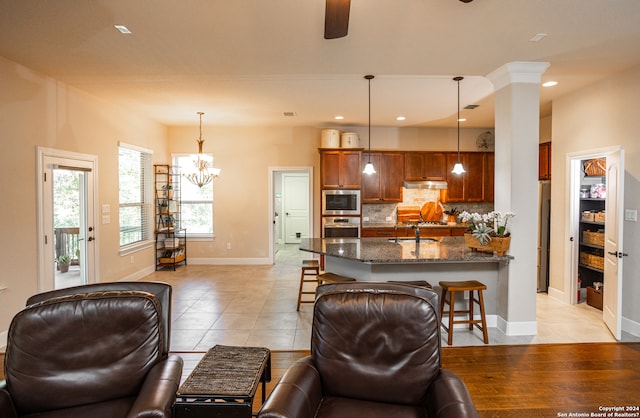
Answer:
[{"xmin": 550, "ymin": 67, "xmax": 640, "ymax": 330}]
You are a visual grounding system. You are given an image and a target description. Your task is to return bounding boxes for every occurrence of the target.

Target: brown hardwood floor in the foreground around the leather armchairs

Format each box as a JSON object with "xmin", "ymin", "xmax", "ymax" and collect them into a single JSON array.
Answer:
[{"xmin": 0, "ymin": 343, "xmax": 640, "ymax": 418}]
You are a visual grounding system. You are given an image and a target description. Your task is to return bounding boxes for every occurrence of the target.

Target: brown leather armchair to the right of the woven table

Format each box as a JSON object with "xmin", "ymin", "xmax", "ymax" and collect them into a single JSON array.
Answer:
[{"xmin": 258, "ymin": 282, "xmax": 478, "ymax": 418}]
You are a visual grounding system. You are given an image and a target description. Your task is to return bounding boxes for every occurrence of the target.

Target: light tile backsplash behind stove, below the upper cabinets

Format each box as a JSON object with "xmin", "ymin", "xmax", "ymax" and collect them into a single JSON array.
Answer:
[{"xmin": 362, "ymin": 188, "xmax": 493, "ymax": 224}]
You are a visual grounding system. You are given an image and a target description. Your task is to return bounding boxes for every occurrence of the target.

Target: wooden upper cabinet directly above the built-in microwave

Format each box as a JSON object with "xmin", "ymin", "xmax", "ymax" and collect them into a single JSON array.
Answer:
[{"xmin": 320, "ymin": 150, "xmax": 362, "ymax": 189}]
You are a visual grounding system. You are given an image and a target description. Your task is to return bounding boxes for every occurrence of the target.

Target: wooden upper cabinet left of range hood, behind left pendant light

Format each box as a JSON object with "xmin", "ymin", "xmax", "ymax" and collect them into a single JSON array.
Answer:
[{"xmin": 361, "ymin": 152, "xmax": 404, "ymax": 203}]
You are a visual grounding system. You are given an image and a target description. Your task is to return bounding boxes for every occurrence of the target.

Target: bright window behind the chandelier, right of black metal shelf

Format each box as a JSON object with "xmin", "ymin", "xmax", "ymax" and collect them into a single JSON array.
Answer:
[{"xmin": 172, "ymin": 153, "xmax": 213, "ymax": 238}]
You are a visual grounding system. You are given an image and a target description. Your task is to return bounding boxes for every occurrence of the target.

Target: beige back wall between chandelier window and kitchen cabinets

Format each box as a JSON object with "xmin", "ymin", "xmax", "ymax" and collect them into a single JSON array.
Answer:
[{"xmin": 169, "ymin": 125, "xmax": 320, "ymax": 263}]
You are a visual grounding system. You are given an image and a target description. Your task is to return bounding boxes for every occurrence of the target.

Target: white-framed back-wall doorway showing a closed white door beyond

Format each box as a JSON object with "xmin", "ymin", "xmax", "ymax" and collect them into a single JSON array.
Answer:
[{"xmin": 269, "ymin": 167, "xmax": 313, "ymax": 264}]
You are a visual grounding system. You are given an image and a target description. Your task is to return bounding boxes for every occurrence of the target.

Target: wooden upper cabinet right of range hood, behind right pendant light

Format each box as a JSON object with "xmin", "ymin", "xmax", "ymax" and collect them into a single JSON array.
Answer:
[{"xmin": 446, "ymin": 152, "xmax": 494, "ymax": 202}]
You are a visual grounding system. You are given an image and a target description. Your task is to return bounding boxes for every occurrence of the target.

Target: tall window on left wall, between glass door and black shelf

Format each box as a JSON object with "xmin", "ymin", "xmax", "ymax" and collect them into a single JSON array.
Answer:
[{"xmin": 118, "ymin": 142, "xmax": 153, "ymax": 251}]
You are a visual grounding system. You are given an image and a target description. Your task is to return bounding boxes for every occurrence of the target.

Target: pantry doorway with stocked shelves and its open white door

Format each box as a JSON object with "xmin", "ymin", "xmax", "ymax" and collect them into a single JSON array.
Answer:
[{"xmin": 565, "ymin": 147, "xmax": 624, "ymax": 340}]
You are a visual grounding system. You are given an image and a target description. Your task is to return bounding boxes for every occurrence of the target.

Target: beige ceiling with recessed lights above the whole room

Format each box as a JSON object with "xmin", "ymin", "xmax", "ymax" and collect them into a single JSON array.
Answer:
[{"xmin": 0, "ymin": 0, "xmax": 640, "ymax": 128}]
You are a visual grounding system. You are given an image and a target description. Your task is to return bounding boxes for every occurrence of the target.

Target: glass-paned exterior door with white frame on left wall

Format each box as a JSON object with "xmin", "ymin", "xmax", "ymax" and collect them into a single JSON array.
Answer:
[{"xmin": 37, "ymin": 148, "xmax": 97, "ymax": 292}]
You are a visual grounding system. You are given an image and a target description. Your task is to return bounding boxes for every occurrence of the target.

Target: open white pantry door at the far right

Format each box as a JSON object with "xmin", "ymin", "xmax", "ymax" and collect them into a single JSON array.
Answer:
[{"xmin": 602, "ymin": 149, "xmax": 624, "ymax": 340}]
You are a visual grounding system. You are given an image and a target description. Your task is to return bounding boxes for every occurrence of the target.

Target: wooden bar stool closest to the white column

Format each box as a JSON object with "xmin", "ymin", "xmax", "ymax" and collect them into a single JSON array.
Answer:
[{"xmin": 439, "ymin": 280, "xmax": 489, "ymax": 345}]
